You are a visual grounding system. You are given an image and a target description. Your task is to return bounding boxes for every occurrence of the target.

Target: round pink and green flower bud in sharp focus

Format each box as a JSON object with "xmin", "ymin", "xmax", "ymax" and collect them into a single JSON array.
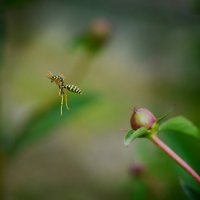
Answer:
[{"xmin": 131, "ymin": 108, "xmax": 157, "ymax": 130}]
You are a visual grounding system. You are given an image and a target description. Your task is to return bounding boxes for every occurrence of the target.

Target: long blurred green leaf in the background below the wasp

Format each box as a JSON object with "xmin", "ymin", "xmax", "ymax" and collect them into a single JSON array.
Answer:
[{"xmin": 9, "ymin": 95, "xmax": 95, "ymax": 155}]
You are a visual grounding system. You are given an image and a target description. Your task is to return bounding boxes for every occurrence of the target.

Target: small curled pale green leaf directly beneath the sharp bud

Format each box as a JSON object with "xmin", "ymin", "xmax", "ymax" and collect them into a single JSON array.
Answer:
[{"xmin": 124, "ymin": 127, "xmax": 147, "ymax": 146}]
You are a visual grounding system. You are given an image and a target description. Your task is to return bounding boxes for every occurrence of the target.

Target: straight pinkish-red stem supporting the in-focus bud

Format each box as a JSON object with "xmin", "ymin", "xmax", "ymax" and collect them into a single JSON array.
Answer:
[{"xmin": 150, "ymin": 135, "xmax": 200, "ymax": 184}]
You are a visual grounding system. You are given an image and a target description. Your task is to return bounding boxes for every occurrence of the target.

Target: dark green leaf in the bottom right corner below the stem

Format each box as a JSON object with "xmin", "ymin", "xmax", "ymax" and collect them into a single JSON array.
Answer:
[{"xmin": 181, "ymin": 182, "xmax": 200, "ymax": 200}]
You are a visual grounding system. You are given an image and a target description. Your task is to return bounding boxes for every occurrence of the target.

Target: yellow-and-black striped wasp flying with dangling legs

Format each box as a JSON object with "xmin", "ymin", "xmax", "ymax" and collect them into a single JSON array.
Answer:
[{"xmin": 47, "ymin": 72, "xmax": 82, "ymax": 115}]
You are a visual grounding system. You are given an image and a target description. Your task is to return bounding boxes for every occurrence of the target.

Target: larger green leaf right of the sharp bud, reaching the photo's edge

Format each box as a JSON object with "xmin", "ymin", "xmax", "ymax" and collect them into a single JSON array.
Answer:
[{"xmin": 159, "ymin": 116, "xmax": 200, "ymax": 139}]
